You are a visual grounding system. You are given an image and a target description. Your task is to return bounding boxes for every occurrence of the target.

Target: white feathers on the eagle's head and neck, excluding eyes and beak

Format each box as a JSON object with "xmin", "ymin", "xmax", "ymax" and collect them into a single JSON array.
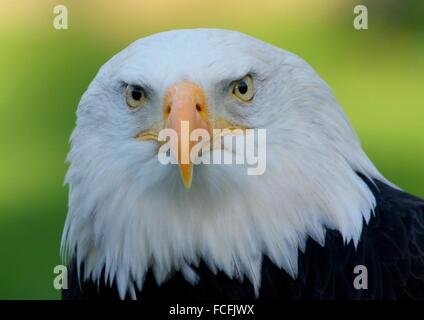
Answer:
[{"xmin": 62, "ymin": 29, "xmax": 388, "ymax": 297}]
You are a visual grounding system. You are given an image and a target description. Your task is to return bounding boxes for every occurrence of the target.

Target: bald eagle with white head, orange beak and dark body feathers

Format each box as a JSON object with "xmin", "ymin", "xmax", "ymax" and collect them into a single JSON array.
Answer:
[{"xmin": 61, "ymin": 29, "xmax": 424, "ymax": 301}]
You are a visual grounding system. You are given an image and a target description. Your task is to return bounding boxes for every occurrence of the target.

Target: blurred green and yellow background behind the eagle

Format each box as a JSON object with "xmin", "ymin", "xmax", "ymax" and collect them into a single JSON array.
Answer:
[{"xmin": 0, "ymin": 0, "xmax": 424, "ymax": 299}]
